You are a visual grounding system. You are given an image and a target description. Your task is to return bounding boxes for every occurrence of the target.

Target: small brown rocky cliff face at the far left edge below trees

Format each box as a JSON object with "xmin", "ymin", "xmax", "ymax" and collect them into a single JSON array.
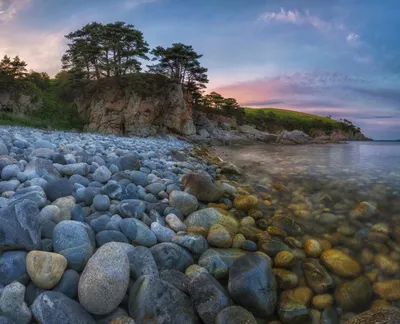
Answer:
[{"xmin": 0, "ymin": 85, "xmax": 43, "ymax": 114}]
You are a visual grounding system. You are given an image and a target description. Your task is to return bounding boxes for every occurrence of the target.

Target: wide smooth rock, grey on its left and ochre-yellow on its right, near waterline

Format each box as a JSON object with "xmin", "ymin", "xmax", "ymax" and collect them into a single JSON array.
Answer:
[{"xmin": 184, "ymin": 208, "xmax": 239, "ymax": 233}]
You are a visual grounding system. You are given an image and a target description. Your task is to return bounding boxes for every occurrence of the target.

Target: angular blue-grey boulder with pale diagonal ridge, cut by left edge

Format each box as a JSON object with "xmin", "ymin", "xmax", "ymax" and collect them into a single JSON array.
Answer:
[{"xmin": 0, "ymin": 200, "xmax": 40, "ymax": 251}]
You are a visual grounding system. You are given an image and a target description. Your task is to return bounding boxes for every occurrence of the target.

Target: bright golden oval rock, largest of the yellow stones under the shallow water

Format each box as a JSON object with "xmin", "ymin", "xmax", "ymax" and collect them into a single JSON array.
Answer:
[{"xmin": 321, "ymin": 249, "xmax": 361, "ymax": 278}]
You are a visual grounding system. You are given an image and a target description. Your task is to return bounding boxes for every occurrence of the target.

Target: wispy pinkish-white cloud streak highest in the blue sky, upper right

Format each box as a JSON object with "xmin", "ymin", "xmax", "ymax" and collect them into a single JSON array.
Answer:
[{"xmin": 260, "ymin": 8, "xmax": 345, "ymax": 32}]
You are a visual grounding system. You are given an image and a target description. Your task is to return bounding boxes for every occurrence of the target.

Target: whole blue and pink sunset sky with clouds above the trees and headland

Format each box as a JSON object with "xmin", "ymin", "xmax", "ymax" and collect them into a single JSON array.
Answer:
[{"xmin": 0, "ymin": 0, "xmax": 400, "ymax": 139}]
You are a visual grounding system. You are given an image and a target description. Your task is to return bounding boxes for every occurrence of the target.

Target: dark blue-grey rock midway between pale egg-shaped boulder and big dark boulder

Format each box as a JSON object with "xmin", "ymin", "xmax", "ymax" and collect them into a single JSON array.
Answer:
[{"xmin": 150, "ymin": 242, "xmax": 194, "ymax": 272}]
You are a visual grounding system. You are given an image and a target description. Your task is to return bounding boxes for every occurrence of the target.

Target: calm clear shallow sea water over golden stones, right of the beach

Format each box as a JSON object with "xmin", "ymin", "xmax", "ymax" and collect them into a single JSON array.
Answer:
[{"xmin": 216, "ymin": 142, "xmax": 400, "ymax": 318}]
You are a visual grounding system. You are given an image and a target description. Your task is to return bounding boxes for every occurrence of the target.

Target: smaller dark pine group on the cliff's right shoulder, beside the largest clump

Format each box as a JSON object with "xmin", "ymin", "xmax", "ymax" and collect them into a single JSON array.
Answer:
[{"xmin": 148, "ymin": 43, "xmax": 208, "ymax": 93}]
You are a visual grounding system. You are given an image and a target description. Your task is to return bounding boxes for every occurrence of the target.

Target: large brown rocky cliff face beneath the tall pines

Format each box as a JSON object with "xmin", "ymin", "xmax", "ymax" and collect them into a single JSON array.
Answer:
[{"xmin": 75, "ymin": 73, "xmax": 196, "ymax": 136}]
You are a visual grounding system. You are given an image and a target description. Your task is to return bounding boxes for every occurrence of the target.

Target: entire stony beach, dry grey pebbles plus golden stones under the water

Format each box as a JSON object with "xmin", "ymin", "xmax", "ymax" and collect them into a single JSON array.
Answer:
[{"xmin": 0, "ymin": 127, "xmax": 400, "ymax": 324}]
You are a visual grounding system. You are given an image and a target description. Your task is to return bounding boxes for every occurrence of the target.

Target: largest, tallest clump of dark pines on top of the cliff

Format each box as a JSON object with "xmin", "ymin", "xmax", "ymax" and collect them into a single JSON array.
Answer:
[{"xmin": 62, "ymin": 21, "xmax": 149, "ymax": 80}]
